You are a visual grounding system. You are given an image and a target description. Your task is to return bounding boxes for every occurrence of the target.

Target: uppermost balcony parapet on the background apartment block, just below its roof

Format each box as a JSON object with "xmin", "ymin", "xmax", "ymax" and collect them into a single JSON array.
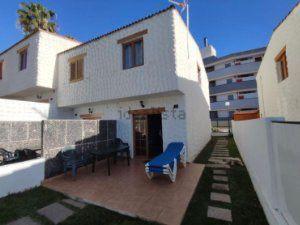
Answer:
[{"xmin": 207, "ymin": 62, "xmax": 260, "ymax": 81}]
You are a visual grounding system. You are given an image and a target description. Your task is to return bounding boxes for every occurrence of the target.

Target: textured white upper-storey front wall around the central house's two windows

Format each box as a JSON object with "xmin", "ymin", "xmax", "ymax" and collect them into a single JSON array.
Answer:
[{"xmin": 58, "ymin": 10, "xmax": 177, "ymax": 106}]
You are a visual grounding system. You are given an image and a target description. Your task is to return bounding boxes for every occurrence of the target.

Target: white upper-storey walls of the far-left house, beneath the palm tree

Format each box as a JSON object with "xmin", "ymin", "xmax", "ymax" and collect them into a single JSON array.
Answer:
[{"xmin": 0, "ymin": 31, "xmax": 79, "ymax": 98}]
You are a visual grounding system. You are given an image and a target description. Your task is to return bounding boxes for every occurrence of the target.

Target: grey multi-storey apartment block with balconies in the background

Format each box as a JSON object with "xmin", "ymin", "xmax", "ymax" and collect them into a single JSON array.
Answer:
[{"xmin": 201, "ymin": 38, "xmax": 266, "ymax": 126}]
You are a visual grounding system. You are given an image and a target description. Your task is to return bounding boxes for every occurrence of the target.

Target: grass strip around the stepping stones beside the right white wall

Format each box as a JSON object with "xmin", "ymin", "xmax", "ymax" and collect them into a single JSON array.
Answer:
[{"xmin": 182, "ymin": 137, "xmax": 268, "ymax": 225}]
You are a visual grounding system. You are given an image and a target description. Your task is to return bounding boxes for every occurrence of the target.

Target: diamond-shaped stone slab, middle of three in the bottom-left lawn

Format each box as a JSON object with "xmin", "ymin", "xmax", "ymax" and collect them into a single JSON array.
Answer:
[{"xmin": 37, "ymin": 202, "xmax": 74, "ymax": 224}]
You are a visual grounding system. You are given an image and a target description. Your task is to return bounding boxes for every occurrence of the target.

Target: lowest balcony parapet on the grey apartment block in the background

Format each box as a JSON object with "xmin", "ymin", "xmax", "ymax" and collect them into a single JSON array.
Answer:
[{"xmin": 210, "ymin": 98, "xmax": 258, "ymax": 111}]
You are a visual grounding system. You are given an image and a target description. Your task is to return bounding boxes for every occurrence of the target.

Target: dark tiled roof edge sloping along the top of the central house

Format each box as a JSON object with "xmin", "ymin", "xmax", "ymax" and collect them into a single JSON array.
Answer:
[{"xmin": 59, "ymin": 5, "xmax": 176, "ymax": 54}]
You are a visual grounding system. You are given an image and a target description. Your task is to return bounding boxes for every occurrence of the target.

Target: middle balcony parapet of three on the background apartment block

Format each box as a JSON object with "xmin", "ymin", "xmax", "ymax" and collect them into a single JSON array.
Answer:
[{"xmin": 209, "ymin": 80, "xmax": 256, "ymax": 95}]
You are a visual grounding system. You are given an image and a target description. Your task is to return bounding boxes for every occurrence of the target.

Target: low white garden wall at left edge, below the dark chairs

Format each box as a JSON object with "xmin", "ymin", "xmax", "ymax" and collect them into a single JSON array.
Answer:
[{"xmin": 0, "ymin": 158, "xmax": 45, "ymax": 198}]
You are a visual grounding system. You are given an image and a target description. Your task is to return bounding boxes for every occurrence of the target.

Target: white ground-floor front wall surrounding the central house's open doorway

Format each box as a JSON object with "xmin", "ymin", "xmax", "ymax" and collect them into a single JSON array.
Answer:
[{"xmin": 75, "ymin": 94, "xmax": 187, "ymax": 159}]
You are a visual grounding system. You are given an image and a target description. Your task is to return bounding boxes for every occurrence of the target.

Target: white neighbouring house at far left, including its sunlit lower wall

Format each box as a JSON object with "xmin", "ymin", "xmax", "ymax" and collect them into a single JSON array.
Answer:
[{"xmin": 0, "ymin": 30, "xmax": 80, "ymax": 121}]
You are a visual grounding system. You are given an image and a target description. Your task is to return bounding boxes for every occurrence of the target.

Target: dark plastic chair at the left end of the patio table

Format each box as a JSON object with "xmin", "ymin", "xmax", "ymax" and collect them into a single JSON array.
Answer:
[{"xmin": 61, "ymin": 146, "xmax": 88, "ymax": 178}]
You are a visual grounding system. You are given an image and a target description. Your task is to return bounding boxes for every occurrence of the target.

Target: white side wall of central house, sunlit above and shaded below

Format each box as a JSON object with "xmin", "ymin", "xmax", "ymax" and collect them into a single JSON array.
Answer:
[{"xmin": 173, "ymin": 10, "xmax": 211, "ymax": 160}]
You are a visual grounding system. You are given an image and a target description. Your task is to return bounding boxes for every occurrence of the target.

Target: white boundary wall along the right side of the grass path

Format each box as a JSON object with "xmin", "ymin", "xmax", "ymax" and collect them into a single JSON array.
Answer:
[{"xmin": 232, "ymin": 118, "xmax": 300, "ymax": 225}]
